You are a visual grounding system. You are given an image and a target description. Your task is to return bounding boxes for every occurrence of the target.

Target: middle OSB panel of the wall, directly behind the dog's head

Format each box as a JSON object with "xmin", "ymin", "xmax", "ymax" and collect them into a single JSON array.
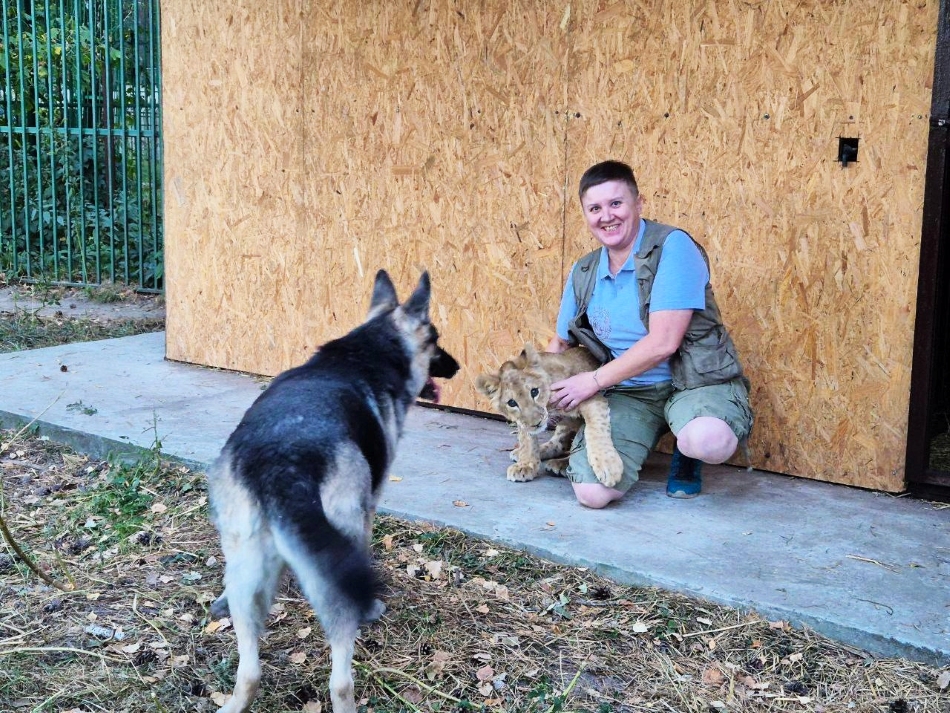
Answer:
[{"xmin": 288, "ymin": 0, "xmax": 566, "ymax": 408}]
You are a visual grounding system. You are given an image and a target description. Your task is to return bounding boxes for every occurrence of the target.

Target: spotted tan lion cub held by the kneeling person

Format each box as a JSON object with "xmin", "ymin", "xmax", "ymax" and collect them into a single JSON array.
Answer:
[{"xmin": 475, "ymin": 344, "xmax": 623, "ymax": 488}]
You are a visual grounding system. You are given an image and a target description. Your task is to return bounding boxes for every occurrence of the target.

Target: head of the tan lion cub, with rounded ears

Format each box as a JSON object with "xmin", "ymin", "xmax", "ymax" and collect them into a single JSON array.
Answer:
[{"xmin": 475, "ymin": 344, "xmax": 551, "ymax": 431}]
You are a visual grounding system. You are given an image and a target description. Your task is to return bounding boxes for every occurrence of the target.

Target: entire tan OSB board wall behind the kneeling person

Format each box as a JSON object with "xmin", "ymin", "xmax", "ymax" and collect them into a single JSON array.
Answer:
[{"xmin": 162, "ymin": 0, "xmax": 937, "ymax": 491}]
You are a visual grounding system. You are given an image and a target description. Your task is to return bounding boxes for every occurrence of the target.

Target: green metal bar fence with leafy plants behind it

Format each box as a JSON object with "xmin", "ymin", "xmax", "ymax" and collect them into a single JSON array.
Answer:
[{"xmin": 0, "ymin": 0, "xmax": 163, "ymax": 292}]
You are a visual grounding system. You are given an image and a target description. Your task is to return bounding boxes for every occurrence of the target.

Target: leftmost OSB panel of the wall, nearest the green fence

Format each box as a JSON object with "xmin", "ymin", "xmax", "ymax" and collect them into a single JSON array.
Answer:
[{"xmin": 162, "ymin": 0, "xmax": 304, "ymax": 372}]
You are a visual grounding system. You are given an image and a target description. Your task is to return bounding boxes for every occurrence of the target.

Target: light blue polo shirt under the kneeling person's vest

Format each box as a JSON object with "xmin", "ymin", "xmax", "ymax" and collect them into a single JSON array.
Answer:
[{"xmin": 557, "ymin": 220, "xmax": 709, "ymax": 386}]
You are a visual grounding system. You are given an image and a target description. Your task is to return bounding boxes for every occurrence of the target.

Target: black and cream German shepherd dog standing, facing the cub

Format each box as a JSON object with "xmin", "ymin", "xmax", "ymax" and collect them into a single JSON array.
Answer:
[{"xmin": 208, "ymin": 270, "xmax": 459, "ymax": 713}]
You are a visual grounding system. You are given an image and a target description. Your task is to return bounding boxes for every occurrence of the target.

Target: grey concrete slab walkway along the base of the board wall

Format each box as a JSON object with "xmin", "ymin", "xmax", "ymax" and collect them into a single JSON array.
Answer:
[{"xmin": 0, "ymin": 333, "xmax": 950, "ymax": 665}]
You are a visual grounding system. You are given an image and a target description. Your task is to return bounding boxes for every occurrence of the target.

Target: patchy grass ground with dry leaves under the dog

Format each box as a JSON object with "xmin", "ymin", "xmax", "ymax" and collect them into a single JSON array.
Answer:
[{"xmin": 0, "ymin": 432, "xmax": 950, "ymax": 713}]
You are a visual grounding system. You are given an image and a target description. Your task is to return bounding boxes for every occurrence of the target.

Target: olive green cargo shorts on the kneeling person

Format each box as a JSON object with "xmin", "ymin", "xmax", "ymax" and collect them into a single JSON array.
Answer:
[{"xmin": 567, "ymin": 378, "xmax": 753, "ymax": 492}]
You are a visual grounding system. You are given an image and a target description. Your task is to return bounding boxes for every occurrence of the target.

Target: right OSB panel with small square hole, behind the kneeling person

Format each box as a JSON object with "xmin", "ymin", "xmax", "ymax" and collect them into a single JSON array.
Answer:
[{"xmin": 567, "ymin": 0, "xmax": 937, "ymax": 490}]
